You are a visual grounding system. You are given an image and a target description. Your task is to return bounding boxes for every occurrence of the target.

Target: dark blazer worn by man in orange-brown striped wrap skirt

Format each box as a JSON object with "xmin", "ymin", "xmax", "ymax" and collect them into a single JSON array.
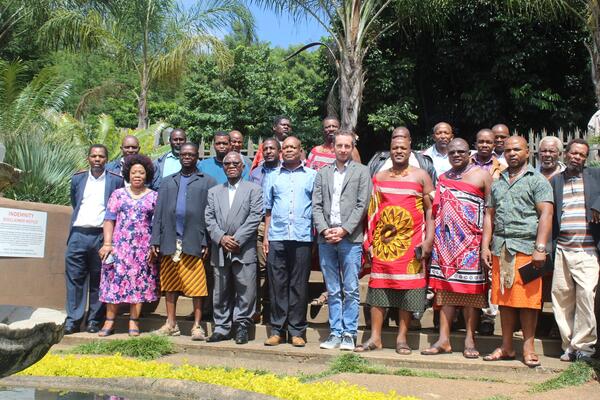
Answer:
[{"xmin": 150, "ymin": 171, "xmax": 216, "ymax": 257}]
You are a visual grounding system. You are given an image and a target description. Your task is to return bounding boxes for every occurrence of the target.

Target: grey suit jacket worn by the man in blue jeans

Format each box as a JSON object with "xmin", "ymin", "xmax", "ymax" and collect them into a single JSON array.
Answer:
[{"xmin": 312, "ymin": 161, "xmax": 372, "ymax": 243}]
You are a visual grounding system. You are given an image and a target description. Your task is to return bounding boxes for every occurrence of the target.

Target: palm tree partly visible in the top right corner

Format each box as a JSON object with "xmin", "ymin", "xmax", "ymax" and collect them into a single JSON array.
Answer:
[{"xmin": 506, "ymin": 0, "xmax": 600, "ymax": 107}]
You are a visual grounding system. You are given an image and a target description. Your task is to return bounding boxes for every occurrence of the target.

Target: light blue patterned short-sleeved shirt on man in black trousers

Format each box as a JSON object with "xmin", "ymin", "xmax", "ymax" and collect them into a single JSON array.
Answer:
[{"xmin": 264, "ymin": 164, "xmax": 317, "ymax": 242}]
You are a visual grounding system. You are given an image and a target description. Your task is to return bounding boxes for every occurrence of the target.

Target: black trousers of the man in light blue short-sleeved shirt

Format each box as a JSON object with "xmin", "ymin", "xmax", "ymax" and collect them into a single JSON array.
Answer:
[{"xmin": 267, "ymin": 240, "xmax": 312, "ymax": 336}]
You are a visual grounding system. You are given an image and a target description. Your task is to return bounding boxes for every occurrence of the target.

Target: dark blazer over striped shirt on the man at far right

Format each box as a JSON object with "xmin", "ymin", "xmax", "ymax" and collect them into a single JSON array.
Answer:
[{"xmin": 550, "ymin": 168, "xmax": 600, "ymax": 253}]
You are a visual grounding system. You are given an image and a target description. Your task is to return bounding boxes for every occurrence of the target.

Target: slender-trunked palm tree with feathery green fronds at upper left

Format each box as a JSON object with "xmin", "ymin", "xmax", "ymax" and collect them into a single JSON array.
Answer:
[{"xmin": 39, "ymin": 0, "xmax": 254, "ymax": 128}]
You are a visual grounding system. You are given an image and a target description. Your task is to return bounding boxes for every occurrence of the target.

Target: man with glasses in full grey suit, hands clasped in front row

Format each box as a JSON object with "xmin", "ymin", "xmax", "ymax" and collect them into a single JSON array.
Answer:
[{"xmin": 205, "ymin": 151, "xmax": 263, "ymax": 344}]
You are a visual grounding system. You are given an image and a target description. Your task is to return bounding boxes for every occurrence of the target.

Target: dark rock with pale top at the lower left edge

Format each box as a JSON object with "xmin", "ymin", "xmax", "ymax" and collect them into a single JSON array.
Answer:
[{"xmin": 0, "ymin": 305, "xmax": 66, "ymax": 378}]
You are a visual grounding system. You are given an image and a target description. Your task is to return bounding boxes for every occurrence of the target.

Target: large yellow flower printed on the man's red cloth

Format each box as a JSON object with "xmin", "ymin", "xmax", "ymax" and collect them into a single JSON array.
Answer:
[{"xmin": 373, "ymin": 206, "xmax": 413, "ymax": 261}]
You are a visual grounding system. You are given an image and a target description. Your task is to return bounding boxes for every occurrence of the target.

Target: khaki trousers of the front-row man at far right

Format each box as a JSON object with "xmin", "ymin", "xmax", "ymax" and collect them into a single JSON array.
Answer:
[{"xmin": 552, "ymin": 248, "xmax": 600, "ymax": 356}]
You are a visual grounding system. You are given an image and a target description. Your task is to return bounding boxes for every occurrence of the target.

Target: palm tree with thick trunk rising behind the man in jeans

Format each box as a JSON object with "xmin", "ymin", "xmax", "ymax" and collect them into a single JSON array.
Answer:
[{"xmin": 251, "ymin": 0, "xmax": 451, "ymax": 130}]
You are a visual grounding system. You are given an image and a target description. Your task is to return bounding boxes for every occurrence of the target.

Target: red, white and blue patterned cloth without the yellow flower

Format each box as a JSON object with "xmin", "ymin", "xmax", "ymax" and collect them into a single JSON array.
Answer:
[{"xmin": 429, "ymin": 175, "xmax": 487, "ymax": 294}]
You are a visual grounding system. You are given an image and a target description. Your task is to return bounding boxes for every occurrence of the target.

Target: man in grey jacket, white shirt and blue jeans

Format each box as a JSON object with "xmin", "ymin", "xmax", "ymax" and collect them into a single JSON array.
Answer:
[{"xmin": 312, "ymin": 131, "xmax": 371, "ymax": 350}]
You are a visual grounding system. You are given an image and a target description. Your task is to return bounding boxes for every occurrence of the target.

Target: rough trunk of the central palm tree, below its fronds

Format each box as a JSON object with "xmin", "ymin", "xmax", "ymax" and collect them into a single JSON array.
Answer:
[{"xmin": 340, "ymin": 50, "xmax": 365, "ymax": 131}]
